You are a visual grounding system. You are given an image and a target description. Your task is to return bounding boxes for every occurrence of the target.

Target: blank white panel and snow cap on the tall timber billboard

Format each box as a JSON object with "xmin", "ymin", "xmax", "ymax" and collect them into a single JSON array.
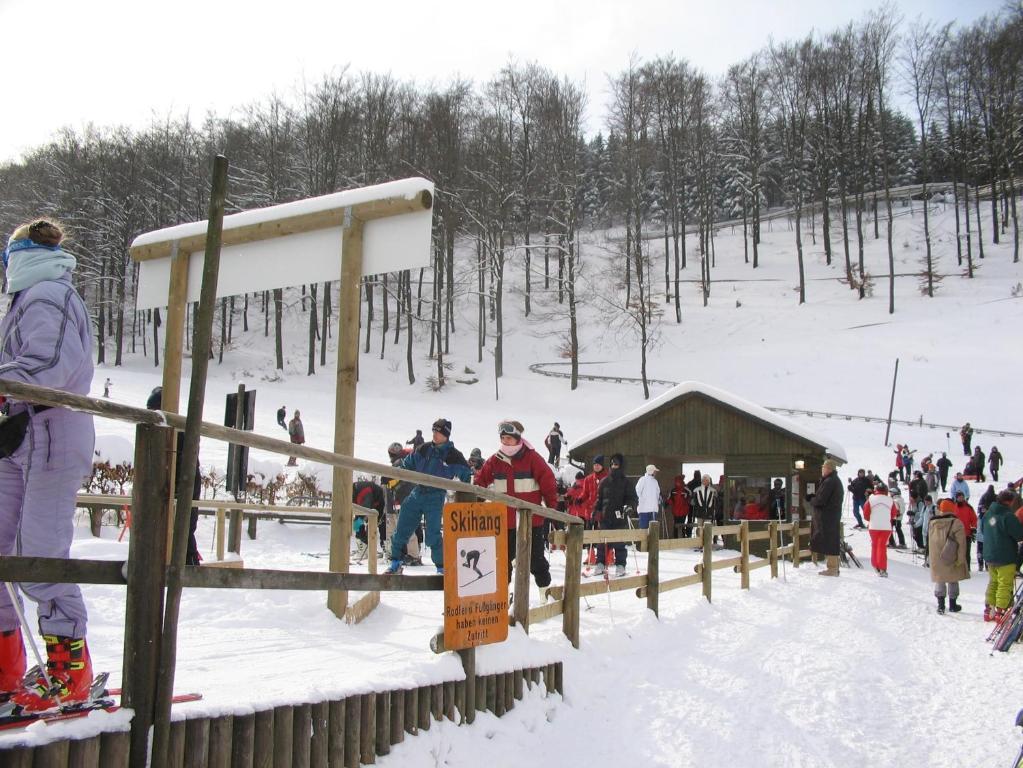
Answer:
[{"xmin": 131, "ymin": 178, "xmax": 434, "ymax": 309}]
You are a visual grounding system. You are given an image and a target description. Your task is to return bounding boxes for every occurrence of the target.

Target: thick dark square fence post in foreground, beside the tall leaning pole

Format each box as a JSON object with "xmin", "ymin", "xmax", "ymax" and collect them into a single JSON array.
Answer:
[{"xmin": 121, "ymin": 424, "xmax": 175, "ymax": 765}]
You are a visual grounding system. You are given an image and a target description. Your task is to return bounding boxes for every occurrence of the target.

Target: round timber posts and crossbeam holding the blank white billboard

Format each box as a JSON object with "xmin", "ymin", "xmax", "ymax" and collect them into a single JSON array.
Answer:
[{"xmin": 129, "ymin": 179, "xmax": 434, "ymax": 619}]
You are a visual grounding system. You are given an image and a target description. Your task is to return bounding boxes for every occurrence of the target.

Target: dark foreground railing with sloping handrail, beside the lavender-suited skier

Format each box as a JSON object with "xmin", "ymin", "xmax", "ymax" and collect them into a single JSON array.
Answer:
[{"xmin": 0, "ymin": 379, "xmax": 582, "ymax": 768}]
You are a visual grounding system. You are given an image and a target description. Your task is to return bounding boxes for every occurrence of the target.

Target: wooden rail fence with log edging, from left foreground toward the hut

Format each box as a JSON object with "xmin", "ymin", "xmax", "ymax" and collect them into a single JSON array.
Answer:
[{"xmin": 0, "ymin": 380, "xmax": 809, "ymax": 768}]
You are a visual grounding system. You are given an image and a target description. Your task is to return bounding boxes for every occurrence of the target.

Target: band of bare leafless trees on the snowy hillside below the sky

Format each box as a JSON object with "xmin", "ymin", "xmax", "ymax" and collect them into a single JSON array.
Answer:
[{"xmin": 0, "ymin": 8, "xmax": 1023, "ymax": 388}]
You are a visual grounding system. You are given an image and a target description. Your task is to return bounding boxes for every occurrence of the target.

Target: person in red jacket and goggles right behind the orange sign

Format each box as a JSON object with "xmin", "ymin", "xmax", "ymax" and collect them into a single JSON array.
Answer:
[{"xmin": 473, "ymin": 420, "xmax": 558, "ymax": 591}]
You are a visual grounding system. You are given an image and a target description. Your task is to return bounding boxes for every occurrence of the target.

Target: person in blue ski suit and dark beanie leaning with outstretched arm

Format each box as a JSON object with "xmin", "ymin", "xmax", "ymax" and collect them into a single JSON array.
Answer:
[{"xmin": 387, "ymin": 418, "xmax": 472, "ymax": 574}]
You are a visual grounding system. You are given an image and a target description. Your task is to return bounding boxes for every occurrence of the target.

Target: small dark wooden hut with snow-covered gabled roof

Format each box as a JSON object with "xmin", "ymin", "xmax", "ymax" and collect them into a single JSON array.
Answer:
[{"xmin": 569, "ymin": 381, "xmax": 846, "ymax": 519}]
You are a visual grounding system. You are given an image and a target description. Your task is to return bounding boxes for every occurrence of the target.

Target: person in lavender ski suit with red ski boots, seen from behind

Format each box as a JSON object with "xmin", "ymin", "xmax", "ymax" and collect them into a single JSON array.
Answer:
[{"xmin": 0, "ymin": 220, "xmax": 95, "ymax": 712}]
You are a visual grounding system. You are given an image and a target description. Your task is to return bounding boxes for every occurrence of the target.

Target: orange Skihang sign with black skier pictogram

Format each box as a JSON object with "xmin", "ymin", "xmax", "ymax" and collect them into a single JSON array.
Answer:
[{"xmin": 444, "ymin": 502, "xmax": 508, "ymax": 650}]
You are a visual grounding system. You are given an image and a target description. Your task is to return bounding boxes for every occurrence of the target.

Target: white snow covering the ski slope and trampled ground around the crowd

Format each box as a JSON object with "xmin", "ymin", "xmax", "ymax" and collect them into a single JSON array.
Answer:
[{"xmin": 0, "ymin": 201, "xmax": 1023, "ymax": 768}]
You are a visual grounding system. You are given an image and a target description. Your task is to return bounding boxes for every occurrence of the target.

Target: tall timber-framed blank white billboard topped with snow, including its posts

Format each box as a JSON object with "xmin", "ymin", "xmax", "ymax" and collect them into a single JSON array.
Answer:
[{"xmin": 130, "ymin": 178, "xmax": 434, "ymax": 617}]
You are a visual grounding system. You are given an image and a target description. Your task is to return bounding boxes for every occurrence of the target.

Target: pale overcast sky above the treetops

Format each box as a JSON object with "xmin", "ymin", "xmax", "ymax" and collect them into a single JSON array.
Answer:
[{"xmin": 0, "ymin": 0, "xmax": 1005, "ymax": 162}]
